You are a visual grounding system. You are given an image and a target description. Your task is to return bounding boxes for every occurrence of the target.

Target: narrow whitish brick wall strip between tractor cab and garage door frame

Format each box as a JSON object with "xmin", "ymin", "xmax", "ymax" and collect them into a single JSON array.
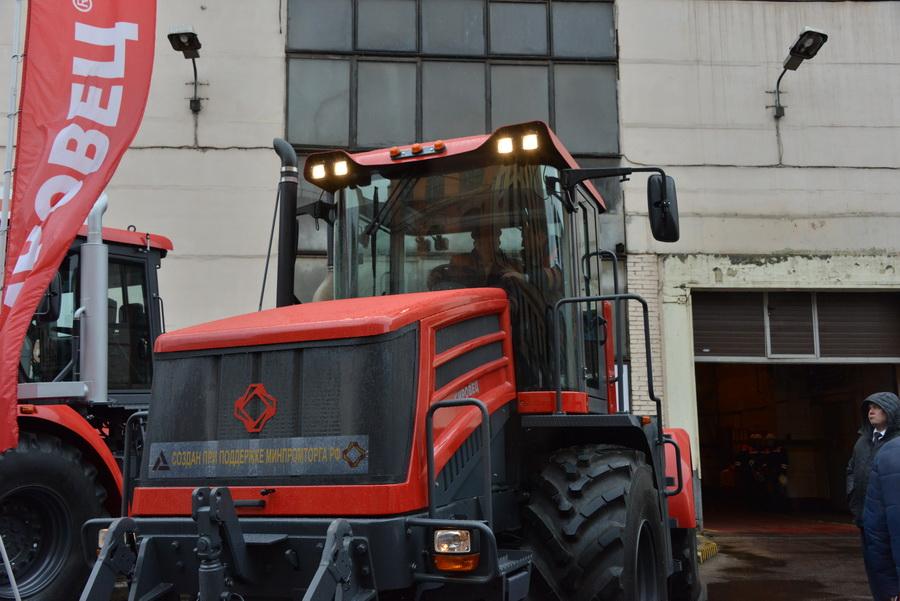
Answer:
[{"xmin": 627, "ymin": 255, "xmax": 664, "ymax": 415}]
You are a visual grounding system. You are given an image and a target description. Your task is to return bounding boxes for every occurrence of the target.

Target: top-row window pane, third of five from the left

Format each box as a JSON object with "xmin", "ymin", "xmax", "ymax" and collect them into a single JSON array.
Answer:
[{"xmin": 422, "ymin": 0, "xmax": 484, "ymax": 54}]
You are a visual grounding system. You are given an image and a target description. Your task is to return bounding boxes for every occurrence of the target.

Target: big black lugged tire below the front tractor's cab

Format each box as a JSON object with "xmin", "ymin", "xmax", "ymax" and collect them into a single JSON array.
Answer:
[{"xmin": 525, "ymin": 444, "xmax": 667, "ymax": 601}]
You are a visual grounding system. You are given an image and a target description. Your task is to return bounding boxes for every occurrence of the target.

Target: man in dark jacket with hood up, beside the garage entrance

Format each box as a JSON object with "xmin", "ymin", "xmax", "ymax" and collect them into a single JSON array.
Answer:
[{"xmin": 847, "ymin": 392, "xmax": 900, "ymax": 528}]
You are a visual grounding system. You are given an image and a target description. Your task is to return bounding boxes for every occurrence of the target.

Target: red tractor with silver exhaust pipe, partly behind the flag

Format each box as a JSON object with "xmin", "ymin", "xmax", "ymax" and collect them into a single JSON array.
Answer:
[{"xmin": 0, "ymin": 200, "xmax": 172, "ymax": 601}]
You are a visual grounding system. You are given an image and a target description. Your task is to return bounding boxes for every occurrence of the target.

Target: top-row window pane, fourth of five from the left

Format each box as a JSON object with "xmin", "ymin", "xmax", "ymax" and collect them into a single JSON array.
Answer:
[{"xmin": 491, "ymin": 2, "xmax": 547, "ymax": 54}]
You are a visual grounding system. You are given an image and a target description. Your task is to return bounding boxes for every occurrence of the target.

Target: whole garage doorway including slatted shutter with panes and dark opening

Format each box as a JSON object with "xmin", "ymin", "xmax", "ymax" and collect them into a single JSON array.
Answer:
[{"xmin": 691, "ymin": 290, "xmax": 900, "ymax": 520}]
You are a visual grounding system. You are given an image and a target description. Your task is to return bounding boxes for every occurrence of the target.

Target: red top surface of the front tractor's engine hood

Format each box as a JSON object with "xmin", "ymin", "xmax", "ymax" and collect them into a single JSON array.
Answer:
[{"xmin": 154, "ymin": 288, "xmax": 506, "ymax": 353}]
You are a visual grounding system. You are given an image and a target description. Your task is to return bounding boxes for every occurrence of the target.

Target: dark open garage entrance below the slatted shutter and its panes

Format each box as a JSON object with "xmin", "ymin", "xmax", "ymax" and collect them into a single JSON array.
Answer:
[{"xmin": 696, "ymin": 363, "xmax": 897, "ymax": 520}]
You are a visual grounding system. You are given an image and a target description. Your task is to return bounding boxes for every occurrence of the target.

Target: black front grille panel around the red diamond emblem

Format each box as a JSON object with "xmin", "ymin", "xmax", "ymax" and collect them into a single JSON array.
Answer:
[{"xmin": 141, "ymin": 326, "xmax": 418, "ymax": 485}]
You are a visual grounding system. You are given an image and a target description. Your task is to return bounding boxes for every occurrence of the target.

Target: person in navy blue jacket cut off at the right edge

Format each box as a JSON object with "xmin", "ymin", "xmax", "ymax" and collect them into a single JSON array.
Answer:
[{"xmin": 863, "ymin": 438, "xmax": 900, "ymax": 601}]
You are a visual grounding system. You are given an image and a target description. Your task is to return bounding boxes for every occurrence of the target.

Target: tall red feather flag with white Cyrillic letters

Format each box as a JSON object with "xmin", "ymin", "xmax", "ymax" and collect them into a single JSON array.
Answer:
[{"xmin": 0, "ymin": 0, "xmax": 156, "ymax": 452}]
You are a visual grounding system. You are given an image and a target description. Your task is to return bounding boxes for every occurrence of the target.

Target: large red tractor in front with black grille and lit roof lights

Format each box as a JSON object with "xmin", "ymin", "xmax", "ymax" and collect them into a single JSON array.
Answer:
[{"xmin": 81, "ymin": 122, "xmax": 701, "ymax": 601}]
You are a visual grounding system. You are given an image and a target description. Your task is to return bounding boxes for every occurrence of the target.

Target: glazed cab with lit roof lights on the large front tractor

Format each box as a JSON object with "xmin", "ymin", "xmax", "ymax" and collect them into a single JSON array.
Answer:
[{"xmin": 300, "ymin": 122, "xmax": 604, "ymax": 396}]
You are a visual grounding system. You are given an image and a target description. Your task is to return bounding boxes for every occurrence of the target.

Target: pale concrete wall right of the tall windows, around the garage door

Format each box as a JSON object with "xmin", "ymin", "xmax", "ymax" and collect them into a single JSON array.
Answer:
[{"xmin": 617, "ymin": 0, "xmax": 900, "ymax": 460}]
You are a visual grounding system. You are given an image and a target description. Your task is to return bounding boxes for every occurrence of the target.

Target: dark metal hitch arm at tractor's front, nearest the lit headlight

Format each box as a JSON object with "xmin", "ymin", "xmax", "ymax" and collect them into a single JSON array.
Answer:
[{"xmin": 303, "ymin": 518, "xmax": 375, "ymax": 601}]
